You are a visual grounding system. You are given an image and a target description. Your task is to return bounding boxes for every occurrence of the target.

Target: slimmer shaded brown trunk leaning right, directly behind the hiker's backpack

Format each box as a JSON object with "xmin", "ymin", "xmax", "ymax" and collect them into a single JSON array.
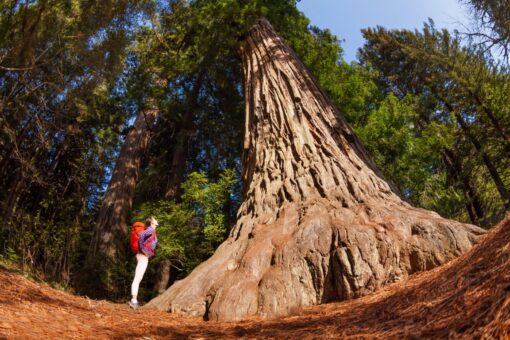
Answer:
[{"xmin": 85, "ymin": 106, "xmax": 158, "ymax": 295}]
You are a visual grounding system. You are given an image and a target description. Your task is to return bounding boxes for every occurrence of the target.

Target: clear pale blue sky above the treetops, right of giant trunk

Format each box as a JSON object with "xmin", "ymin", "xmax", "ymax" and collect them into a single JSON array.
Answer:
[{"xmin": 298, "ymin": 0, "xmax": 469, "ymax": 61}]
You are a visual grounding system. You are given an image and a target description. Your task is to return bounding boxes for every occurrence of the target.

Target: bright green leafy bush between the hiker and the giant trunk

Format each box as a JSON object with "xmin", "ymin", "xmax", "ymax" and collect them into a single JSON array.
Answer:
[{"xmin": 132, "ymin": 169, "xmax": 237, "ymax": 273}]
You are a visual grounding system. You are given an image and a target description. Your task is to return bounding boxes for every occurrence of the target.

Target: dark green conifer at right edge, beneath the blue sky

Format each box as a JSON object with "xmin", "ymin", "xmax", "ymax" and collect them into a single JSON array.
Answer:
[{"xmin": 361, "ymin": 24, "xmax": 510, "ymax": 225}]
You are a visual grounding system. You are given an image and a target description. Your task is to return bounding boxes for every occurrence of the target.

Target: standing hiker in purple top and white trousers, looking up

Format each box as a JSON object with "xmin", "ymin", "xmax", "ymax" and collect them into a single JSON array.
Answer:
[{"xmin": 128, "ymin": 217, "xmax": 158, "ymax": 310}]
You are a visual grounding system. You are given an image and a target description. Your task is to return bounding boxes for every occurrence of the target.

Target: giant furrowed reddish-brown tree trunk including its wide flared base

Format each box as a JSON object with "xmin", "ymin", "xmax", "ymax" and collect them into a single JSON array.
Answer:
[{"xmin": 147, "ymin": 20, "xmax": 483, "ymax": 320}]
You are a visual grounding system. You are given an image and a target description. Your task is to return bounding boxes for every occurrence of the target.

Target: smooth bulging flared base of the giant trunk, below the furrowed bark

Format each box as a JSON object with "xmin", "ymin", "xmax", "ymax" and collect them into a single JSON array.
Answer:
[{"xmin": 147, "ymin": 199, "xmax": 485, "ymax": 320}]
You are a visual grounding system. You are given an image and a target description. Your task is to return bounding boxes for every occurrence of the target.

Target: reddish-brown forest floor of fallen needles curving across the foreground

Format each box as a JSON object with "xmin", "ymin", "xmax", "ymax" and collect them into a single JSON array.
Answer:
[{"xmin": 0, "ymin": 216, "xmax": 510, "ymax": 339}]
